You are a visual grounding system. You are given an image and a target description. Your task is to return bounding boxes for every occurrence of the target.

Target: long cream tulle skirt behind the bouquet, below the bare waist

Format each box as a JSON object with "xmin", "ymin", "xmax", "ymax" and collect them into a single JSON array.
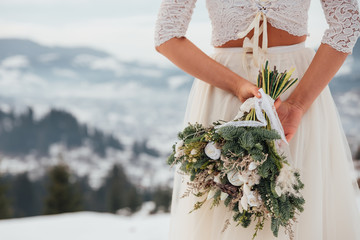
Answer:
[{"xmin": 169, "ymin": 43, "xmax": 360, "ymax": 240}]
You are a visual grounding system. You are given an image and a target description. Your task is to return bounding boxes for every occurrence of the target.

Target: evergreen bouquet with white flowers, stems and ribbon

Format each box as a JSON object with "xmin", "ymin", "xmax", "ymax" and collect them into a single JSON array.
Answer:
[{"xmin": 168, "ymin": 62, "xmax": 305, "ymax": 239}]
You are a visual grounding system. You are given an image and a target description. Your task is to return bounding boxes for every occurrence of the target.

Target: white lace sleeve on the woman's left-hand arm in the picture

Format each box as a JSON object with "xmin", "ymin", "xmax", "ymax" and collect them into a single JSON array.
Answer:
[{"xmin": 155, "ymin": 0, "xmax": 196, "ymax": 46}]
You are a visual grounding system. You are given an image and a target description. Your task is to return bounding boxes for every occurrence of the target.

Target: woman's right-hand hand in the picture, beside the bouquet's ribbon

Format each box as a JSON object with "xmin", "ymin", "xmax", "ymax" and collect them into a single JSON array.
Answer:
[{"xmin": 275, "ymin": 98, "xmax": 304, "ymax": 142}]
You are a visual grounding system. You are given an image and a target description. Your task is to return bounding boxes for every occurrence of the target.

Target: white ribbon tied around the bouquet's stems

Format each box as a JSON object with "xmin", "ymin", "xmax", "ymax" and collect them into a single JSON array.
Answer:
[{"xmin": 215, "ymin": 89, "xmax": 288, "ymax": 144}]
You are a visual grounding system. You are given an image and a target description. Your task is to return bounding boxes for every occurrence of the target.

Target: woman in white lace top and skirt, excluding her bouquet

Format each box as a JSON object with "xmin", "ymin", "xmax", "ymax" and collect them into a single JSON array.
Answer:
[{"xmin": 155, "ymin": 0, "xmax": 360, "ymax": 240}]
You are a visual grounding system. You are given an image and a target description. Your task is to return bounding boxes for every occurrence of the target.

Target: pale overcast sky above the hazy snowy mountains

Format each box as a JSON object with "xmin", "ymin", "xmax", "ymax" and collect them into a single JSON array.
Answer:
[{"xmin": 0, "ymin": 0, "xmax": 356, "ymax": 64}]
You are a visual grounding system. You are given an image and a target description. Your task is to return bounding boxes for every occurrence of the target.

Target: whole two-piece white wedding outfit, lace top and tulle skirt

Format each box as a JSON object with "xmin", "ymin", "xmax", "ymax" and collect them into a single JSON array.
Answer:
[{"xmin": 155, "ymin": 0, "xmax": 360, "ymax": 240}]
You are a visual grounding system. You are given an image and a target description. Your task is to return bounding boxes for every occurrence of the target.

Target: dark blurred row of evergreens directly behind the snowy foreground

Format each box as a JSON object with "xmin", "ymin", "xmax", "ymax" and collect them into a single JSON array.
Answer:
[{"xmin": 0, "ymin": 161, "xmax": 171, "ymax": 219}]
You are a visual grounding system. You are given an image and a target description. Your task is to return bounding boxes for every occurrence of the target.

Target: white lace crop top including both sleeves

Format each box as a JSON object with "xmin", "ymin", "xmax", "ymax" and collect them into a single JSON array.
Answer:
[{"xmin": 155, "ymin": 0, "xmax": 360, "ymax": 53}]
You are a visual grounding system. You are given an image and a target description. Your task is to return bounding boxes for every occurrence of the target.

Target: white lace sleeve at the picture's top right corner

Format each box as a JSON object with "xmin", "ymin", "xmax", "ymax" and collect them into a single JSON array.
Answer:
[{"xmin": 321, "ymin": 0, "xmax": 360, "ymax": 53}]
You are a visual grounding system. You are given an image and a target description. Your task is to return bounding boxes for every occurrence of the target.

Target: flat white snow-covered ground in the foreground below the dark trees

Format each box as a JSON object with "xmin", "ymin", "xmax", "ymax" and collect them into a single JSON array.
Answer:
[{"xmin": 0, "ymin": 204, "xmax": 170, "ymax": 240}]
